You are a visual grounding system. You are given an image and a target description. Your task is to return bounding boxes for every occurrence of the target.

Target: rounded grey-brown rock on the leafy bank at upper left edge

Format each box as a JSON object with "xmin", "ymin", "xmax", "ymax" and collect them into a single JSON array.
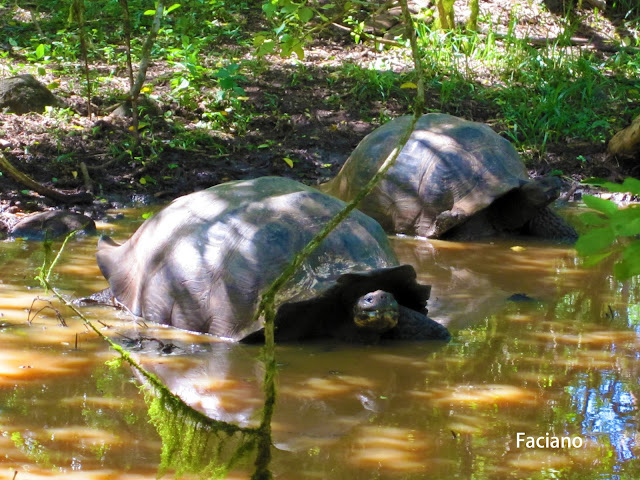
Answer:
[{"xmin": 0, "ymin": 74, "xmax": 62, "ymax": 115}]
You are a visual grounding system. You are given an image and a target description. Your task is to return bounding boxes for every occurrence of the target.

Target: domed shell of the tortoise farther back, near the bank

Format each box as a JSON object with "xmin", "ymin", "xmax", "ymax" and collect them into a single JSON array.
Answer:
[{"xmin": 323, "ymin": 113, "xmax": 530, "ymax": 237}]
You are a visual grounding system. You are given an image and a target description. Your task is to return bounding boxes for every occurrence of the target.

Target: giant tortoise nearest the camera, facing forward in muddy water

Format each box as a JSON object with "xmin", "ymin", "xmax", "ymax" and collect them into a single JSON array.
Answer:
[{"xmin": 97, "ymin": 177, "xmax": 449, "ymax": 342}]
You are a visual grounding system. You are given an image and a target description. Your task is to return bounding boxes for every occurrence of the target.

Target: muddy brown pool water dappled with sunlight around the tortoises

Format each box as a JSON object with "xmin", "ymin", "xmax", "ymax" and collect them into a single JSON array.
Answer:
[{"xmin": 0, "ymin": 212, "xmax": 640, "ymax": 479}]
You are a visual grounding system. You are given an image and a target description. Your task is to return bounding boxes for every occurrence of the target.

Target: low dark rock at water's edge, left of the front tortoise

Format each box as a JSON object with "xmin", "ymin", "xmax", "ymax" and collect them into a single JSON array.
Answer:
[{"xmin": 10, "ymin": 210, "xmax": 96, "ymax": 240}]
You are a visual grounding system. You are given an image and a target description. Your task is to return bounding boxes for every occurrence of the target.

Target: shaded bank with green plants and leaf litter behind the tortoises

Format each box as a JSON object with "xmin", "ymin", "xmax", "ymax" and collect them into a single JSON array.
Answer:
[{"xmin": 0, "ymin": 0, "xmax": 640, "ymax": 214}]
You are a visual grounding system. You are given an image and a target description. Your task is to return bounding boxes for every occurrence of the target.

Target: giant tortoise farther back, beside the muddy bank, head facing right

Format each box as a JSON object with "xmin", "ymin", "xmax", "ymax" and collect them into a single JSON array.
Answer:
[{"xmin": 321, "ymin": 113, "xmax": 577, "ymax": 241}]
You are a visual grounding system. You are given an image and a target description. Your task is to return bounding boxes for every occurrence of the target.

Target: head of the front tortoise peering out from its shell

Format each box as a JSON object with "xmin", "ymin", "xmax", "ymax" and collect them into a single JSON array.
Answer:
[{"xmin": 353, "ymin": 290, "xmax": 400, "ymax": 333}]
